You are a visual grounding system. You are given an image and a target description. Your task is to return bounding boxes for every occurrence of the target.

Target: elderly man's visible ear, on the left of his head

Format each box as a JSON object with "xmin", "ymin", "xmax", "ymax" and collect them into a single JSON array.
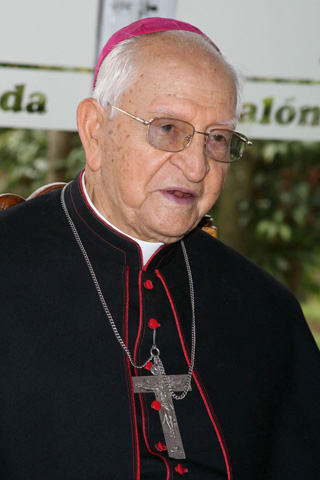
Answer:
[{"xmin": 77, "ymin": 98, "xmax": 103, "ymax": 171}]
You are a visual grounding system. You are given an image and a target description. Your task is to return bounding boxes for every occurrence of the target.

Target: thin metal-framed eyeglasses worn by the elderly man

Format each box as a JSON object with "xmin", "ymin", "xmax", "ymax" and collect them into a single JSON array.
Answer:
[{"xmin": 107, "ymin": 103, "xmax": 252, "ymax": 163}]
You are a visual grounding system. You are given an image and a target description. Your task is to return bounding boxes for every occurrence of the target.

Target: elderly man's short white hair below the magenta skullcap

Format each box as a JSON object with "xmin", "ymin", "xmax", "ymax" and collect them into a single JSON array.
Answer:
[{"xmin": 92, "ymin": 30, "xmax": 244, "ymax": 118}]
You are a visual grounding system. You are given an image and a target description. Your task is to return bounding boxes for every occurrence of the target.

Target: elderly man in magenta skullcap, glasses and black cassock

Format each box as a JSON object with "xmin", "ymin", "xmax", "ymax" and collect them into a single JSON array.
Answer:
[{"xmin": 0, "ymin": 18, "xmax": 320, "ymax": 480}]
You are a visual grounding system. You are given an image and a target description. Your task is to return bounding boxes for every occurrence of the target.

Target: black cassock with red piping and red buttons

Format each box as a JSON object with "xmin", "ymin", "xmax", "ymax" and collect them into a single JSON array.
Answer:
[{"xmin": 0, "ymin": 173, "xmax": 320, "ymax": 480}]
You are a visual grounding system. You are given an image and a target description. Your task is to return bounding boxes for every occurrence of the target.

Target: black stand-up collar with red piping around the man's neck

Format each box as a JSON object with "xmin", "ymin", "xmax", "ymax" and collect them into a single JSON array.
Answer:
[{"xmin": 65, "ymin": 174, "xmax": 179, "ymax": 271}]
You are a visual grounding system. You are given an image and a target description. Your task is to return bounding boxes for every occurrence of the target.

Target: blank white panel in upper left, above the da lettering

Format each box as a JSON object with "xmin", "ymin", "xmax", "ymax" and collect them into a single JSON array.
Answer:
[{"xmin": 0, "ymin": 0, "xmax": 99, "ymax": 68}]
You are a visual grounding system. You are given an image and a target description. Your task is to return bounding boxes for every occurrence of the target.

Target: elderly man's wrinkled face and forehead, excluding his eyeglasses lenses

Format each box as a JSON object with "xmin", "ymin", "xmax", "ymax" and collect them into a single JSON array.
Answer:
[{"xmin": 93, "ymin": 41, "xmax": 236, "ymax": 243}]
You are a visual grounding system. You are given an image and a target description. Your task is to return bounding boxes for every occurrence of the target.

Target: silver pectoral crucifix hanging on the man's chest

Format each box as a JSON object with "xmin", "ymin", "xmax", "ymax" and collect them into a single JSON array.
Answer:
[{"xmin": 132, "ymin": 368, "xmax": 191, "ymax": 459}]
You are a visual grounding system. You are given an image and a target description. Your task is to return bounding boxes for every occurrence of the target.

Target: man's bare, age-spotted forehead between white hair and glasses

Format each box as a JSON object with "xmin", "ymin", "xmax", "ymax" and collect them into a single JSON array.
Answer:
[{"xmin": 119, "ymin": 38, "xmax": 236, "ymax": 123}]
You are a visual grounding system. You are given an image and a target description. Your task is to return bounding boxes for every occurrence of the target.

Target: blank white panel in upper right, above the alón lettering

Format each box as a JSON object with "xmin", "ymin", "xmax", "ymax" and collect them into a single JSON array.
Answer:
[{"xmin": 176, "ymin": 0, "xmax": 320, "ymax": 81}]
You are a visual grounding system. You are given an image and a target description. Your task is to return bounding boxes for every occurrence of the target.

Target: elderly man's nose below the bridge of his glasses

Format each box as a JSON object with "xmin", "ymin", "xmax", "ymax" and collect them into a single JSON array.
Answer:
[{"xmin": 170, "ymin": 135, "xmax": 210, "ymax": 183}]
